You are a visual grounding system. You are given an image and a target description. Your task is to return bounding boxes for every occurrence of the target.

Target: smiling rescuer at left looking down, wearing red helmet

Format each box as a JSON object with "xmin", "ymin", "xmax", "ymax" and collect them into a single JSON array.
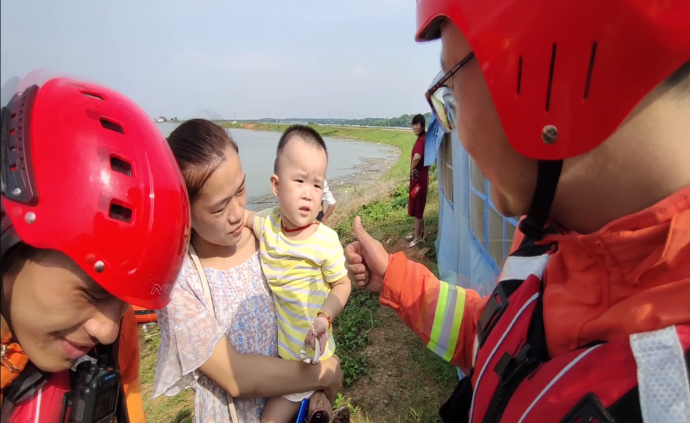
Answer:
[{"xmin": 0, "ymin": 71, "xmax": 190, "ymax": 423}]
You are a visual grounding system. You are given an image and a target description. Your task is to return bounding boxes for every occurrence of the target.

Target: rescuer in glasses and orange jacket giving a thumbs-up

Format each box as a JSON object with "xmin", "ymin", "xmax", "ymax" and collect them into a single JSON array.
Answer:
[{"xmin": 345, "ymin": 0, "xmax": 690, "ymax": 423}]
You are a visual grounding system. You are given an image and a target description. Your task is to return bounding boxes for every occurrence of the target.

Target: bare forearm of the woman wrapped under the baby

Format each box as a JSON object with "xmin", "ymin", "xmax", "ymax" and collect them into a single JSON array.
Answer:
[{"xmin": 199, "ymin": 336, "xmax": 343, "ymax": 402}]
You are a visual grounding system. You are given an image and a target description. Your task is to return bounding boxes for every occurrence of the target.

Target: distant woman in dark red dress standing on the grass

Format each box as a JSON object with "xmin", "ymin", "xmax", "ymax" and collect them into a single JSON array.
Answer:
[{"xmin": 407, "ymin": 115, "xmax": 429, "ymax": 248}]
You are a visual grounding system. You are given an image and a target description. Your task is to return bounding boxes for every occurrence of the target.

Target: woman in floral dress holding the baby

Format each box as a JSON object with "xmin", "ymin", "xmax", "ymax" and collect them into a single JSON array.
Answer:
[{"xmin": 153, "ymin": 119, "xmax": 342, "ymax": 423}]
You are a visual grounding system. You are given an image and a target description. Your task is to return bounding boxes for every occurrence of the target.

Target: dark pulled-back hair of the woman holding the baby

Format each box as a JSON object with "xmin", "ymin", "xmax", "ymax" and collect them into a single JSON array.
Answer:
[{"xmin": 168, "ymin": 119, "xmax": 239, "ymax": 203}]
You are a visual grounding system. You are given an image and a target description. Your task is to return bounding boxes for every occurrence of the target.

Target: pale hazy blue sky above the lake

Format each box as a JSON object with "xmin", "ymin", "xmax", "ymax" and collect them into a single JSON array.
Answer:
[{"xmin": 0, "ymin": 0, "xmax": 440, "ymax": 119}]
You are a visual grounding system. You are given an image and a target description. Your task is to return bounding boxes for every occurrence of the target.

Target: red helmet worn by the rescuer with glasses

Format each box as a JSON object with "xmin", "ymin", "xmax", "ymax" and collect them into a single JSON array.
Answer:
[{"xmin": 416, "ymin": 0, "xmax": 690, "ymax": 160}]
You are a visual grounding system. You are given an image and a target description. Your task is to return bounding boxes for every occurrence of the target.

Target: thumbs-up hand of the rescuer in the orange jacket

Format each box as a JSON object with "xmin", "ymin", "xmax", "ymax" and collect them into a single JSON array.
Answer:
[{"xmin": 345, "ymin": 216, "xmax": 389, "ymax": 292}]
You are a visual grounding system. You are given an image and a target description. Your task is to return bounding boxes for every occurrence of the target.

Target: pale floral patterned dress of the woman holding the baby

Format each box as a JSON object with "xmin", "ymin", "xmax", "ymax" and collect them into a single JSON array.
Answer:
[{"xmin": 153, "ymin": 253, "xmax": 278, "ymax": 423}]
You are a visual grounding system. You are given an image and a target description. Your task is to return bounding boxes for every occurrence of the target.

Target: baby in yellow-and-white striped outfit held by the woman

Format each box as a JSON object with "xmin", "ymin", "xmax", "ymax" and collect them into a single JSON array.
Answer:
[{"xmin": 244, "ymin": 125, "xmax": 351, "ymax": 423}]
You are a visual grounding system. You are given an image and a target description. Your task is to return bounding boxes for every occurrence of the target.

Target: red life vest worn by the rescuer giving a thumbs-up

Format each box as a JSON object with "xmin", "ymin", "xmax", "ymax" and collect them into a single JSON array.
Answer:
[{"xmin": 440, "ymin": 234, "xmax": 690, "ymax": 423}]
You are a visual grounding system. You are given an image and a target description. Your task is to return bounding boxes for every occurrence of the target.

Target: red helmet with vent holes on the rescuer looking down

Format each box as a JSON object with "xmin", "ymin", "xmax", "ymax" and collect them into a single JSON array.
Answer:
[{"xmin": 0, "ymin": 73, "xmax": 190, "ymax": 309}]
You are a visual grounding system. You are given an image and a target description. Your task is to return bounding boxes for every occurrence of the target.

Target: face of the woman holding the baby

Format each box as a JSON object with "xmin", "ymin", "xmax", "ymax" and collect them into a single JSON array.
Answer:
[{"xmin": 192, "ymin": 147, "xmax": 247, "ymax": 246}]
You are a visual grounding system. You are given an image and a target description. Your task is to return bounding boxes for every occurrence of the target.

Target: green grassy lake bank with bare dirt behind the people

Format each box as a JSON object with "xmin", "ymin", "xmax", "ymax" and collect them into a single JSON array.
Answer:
[{"xmin": 141, "ymin": 124, "xmax": 457, "ymax": 423}]
